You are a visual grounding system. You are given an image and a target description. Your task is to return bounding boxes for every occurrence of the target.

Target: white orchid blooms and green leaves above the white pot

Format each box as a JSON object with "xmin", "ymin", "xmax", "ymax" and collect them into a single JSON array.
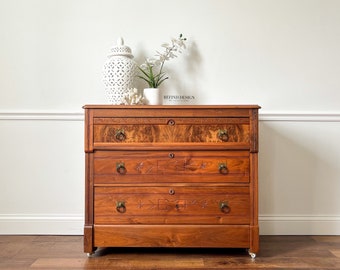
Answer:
[{"xmin": 138, "ymin": 34, "xmax": 187, "ymax": 88}]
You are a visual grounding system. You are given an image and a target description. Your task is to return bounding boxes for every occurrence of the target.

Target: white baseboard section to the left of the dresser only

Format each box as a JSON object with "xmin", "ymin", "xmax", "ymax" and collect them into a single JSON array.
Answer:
[{"xmin": 0, "ymin": 215, "xmax": 84, "ymax": 235}]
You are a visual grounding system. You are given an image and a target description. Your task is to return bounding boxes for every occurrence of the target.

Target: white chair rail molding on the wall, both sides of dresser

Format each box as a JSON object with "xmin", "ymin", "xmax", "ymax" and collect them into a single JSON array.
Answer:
[{"xmin": 0, "ymin": 111, "xmax": 340, "ymax": 122}]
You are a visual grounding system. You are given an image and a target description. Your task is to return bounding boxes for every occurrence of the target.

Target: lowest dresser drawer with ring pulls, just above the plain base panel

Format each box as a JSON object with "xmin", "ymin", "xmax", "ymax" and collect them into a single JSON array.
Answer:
[{"xmin": 94, "ymin": 186, "xmax": 250, "ymax": 225}]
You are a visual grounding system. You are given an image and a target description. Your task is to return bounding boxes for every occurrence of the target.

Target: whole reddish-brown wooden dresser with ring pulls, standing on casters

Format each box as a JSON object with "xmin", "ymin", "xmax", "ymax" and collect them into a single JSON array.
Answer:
[{"xmin": 84, "ymin": 105, "xmax": 260, "ymax": 257}]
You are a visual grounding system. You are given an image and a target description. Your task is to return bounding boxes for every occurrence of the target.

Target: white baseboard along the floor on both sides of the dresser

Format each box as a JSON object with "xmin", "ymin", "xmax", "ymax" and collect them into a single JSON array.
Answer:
[{"xmin": 0, "ymin": 215, "xmax": 340, "ymax": 235}]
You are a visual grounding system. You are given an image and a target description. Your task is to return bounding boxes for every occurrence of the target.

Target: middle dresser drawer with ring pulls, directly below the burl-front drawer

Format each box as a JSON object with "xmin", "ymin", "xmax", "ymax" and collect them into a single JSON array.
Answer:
[{"xmin": 93, "ymin": 151, "xmax": 249, "ymax": 184}]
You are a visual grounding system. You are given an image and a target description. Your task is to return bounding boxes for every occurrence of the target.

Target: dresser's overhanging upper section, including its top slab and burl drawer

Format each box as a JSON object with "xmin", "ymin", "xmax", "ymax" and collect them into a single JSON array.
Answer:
[{"xmin": 85, "ymin": 105, "xmax": 258, "ymax": 152}]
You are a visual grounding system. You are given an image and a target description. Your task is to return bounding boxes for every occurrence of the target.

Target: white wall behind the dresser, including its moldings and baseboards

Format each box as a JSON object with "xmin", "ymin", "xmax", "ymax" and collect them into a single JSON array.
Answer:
[{"xmin": 0, "ymin": 0, "xmax": 340, "ymax": 234}]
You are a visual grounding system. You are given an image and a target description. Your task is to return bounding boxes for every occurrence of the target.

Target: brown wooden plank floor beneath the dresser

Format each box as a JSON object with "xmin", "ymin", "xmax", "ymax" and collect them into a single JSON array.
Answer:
[{"xmin": 0, "ymin": 235, "xmax": 340, "ymax": 270}]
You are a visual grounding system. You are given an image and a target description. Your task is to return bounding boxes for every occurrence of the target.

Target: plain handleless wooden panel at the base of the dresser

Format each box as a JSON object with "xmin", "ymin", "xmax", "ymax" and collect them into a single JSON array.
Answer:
[{"xmin": 94, "ymin": 225, "xmax": 251, "ymax": 248}]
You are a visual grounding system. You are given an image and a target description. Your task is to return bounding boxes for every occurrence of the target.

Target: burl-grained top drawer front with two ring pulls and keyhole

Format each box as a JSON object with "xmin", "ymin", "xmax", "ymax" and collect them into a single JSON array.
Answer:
[{"xmin": 93, "ymin": 117, "xmax": 250, "ymax": 145}]
